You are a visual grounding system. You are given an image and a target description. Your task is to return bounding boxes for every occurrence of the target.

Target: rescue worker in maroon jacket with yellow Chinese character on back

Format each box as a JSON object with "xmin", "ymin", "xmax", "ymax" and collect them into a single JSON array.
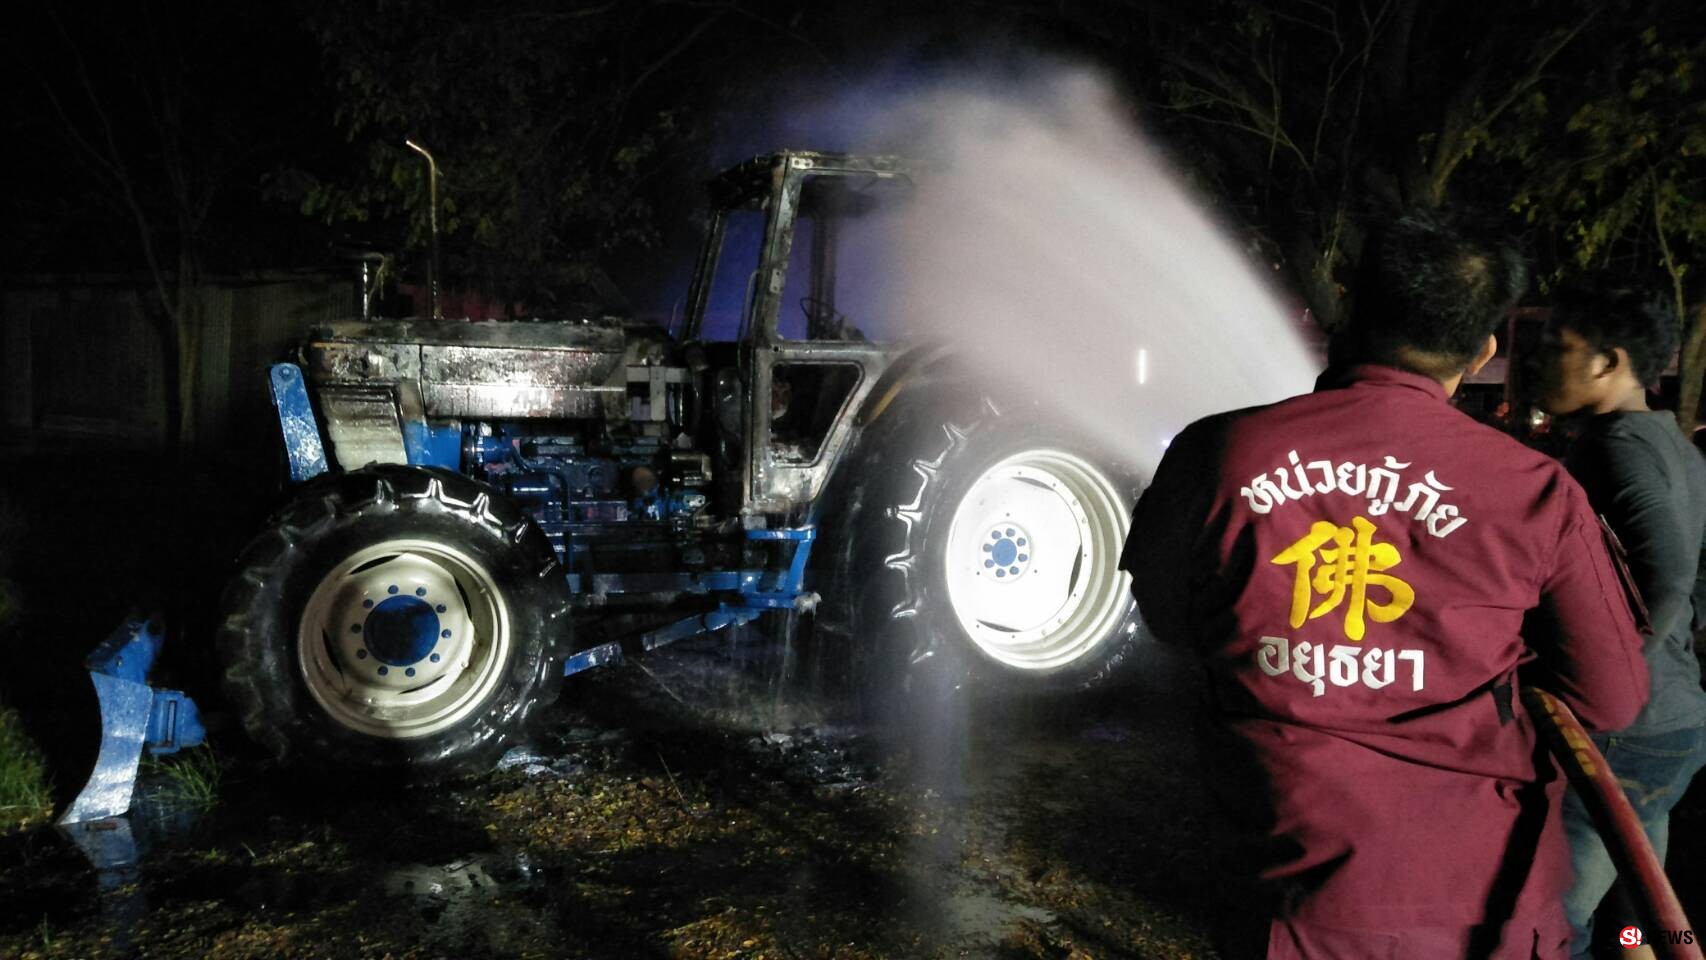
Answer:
[{"xmin": 1121, "ymin": 218, "xmax": 1646, "ymax": 960}]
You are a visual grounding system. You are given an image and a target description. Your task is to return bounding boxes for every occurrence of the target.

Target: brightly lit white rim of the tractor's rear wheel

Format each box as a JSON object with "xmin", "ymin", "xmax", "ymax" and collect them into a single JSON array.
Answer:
[{"xmin": 945, "ymin": 450, "xmax": 1131, "ymax": 670}]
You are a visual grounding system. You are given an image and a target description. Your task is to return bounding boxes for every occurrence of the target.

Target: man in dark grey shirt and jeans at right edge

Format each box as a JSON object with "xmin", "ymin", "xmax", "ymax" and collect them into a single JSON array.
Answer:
[{"xmin": 1542, "ymin": 286, "xmax": 1706, "ymax": 957}]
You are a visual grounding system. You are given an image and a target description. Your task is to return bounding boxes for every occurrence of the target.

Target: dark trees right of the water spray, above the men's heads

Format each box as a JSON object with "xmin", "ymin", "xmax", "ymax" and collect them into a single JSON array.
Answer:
[{"xmin": 1018, "ymin": 0, "xmax": 1706, "ymax": 419}]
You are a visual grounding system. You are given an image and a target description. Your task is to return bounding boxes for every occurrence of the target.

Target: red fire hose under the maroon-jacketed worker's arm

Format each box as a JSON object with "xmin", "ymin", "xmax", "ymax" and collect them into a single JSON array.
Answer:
[{"xmin": 1522, "ymin": 687, "xmax": 1703, "ymax": 960}]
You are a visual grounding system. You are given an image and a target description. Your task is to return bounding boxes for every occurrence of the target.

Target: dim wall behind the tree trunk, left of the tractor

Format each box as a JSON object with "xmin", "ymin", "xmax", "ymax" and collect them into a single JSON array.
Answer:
[{"xmin": 0, "ymin": 275, "xmax": 355, "ymax": 450}]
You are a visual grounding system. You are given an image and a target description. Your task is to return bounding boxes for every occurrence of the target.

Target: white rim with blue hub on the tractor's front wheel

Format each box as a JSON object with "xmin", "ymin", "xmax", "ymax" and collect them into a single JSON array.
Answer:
[{"xmin": 297, "ymin": 541, "xmax": 512, "ymax": 740}]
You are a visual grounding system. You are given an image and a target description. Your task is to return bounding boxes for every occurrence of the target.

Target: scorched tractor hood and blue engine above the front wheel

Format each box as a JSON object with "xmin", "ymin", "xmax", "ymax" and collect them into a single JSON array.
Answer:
[{"xmin": 302, "ymin": 317, "xmax": 713, "ymax": 573}]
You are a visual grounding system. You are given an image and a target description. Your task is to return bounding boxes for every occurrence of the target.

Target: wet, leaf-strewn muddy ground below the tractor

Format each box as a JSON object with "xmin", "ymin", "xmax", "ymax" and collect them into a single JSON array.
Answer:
[{"xmin": 0, "ymin": 636, "xmax": 1706, "ymax": 960}]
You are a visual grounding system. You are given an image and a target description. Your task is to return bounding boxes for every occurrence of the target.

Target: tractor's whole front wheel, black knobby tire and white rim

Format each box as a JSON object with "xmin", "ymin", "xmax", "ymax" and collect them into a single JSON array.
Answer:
[{"xmin": 217, "ymin": 466, "xmax": 570, "ymax": 781}]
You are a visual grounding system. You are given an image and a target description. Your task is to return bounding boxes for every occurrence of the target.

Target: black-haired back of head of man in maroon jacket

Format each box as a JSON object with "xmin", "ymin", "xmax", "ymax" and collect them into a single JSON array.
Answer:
[{"xmin": 1334, "ymin": 213, "xmax": 1529, "ymax": 379}]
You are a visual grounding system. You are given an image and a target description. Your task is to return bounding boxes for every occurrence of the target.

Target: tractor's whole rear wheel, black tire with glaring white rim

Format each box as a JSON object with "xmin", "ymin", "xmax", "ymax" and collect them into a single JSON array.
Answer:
[{"xmin": 850, "ymin": 389, "xmax": 1143, "ymax": 694}]
